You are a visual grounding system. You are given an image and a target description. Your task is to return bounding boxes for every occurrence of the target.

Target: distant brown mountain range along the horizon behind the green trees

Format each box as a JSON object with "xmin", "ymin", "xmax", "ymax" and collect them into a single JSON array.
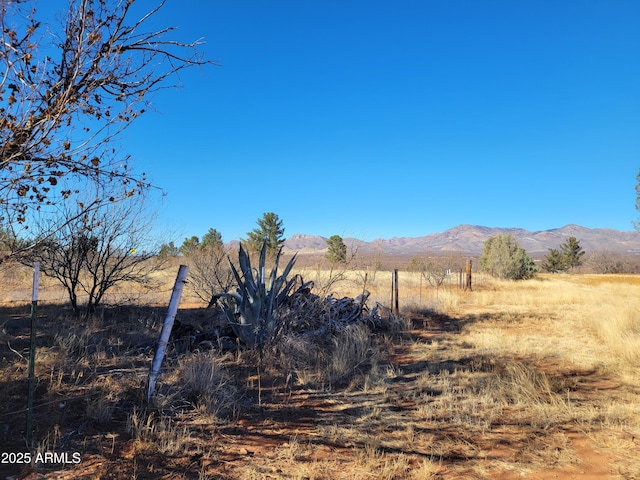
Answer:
[{"xmin": 284, "ymin": 225, "xmax": 640, "ymax": 256}]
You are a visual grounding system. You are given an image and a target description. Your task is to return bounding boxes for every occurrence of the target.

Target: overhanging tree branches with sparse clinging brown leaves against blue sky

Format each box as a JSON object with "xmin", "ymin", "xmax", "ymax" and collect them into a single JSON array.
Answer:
[{"xmin": 0, "ymin": 0, "xmax": 209, "ymax": 256}]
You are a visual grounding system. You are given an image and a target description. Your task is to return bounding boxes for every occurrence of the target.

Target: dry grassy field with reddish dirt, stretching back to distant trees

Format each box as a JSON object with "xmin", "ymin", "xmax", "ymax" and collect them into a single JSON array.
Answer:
[{"xmin": 0, "ymin": 266, "xmax": 640, "ymax": 480}]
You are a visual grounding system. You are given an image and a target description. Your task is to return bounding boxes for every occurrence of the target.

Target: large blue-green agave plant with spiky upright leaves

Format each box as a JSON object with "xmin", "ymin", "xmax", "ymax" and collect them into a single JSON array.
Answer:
[{"xmin": 223, "ymin": 241, "xmax": 296, "ymax": 348}]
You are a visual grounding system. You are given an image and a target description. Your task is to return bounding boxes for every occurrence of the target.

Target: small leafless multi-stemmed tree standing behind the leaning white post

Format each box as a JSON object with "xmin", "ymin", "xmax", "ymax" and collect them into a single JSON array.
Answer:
[{"xmin": 26, "ymin": 186, "xmax": 162, "ymax": 317}]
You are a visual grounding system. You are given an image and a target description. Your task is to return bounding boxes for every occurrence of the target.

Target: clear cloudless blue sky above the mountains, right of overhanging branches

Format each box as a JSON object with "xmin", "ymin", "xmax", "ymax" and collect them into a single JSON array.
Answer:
[{"xmin": 117, "ymin": 0, "xmax": 640, "ymax": 241}]
